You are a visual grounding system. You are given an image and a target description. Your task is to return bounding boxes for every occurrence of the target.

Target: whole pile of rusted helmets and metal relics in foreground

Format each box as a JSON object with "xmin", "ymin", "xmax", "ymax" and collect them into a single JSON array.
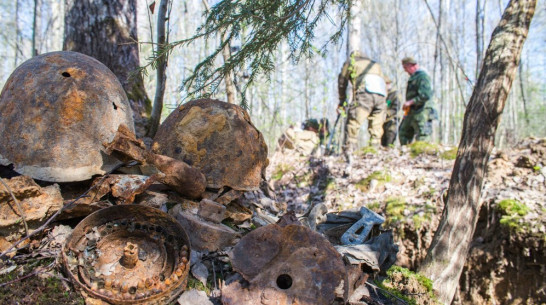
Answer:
[{"xmin": 0, "ymin": 52, "xmax": 396, "ymax": 304}]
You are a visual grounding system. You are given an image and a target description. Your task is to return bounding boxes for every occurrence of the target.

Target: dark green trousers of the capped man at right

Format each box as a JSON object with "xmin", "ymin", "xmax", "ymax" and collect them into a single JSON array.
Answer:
[{"xmin": 399, "ymin": 107, "xmax": 432, "ymax": 145}]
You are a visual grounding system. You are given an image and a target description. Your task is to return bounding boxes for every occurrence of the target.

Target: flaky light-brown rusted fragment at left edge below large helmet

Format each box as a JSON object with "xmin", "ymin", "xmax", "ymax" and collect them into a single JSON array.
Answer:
[{"xmin": 0, "ymin": 176, "xmax": 63, "ymax": 240}]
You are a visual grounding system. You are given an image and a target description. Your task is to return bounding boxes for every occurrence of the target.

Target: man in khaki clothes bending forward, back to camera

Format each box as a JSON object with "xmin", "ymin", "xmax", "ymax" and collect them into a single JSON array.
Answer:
[{"xmin": 338, "ymin": 51, "xmax": 387, "ymax": 163}]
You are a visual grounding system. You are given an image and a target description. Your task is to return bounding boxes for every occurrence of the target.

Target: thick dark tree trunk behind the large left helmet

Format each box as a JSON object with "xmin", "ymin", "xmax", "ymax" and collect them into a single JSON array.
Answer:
[{"xmin": 63, "ymin": 0, "xmax": 152, "ymax": 136}]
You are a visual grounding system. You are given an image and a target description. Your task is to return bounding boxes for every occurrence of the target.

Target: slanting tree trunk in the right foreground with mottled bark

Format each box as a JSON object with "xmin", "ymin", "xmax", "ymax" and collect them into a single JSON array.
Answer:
[{"xmin": 419, "ymin": 0, "xmax": 536, "ymax": 304}]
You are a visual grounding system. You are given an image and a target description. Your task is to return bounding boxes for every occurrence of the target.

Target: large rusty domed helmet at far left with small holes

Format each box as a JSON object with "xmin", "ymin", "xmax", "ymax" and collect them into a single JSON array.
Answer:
[{"xmin": 0, "ymin": 52, "xmax": 134, "ymax": 182}]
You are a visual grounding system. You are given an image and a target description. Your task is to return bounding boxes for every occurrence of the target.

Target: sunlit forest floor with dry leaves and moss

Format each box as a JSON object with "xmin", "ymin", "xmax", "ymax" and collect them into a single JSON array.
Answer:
[{"xmin": 0, "ymin": 139, "xmax": 546, "ymax": 304}]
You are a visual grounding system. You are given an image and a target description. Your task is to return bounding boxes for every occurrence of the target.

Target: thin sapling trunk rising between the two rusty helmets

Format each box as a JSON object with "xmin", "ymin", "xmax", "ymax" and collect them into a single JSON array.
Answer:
[{"xmin": 146, "ymin": 0, "xmax": 169, "ymax": 138}]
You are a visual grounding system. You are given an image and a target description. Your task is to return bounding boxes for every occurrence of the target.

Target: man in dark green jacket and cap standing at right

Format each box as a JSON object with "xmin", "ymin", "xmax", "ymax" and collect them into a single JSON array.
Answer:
[{"xmin": 399, "ymin": 57, "xmax": 434, "ymax": 145}]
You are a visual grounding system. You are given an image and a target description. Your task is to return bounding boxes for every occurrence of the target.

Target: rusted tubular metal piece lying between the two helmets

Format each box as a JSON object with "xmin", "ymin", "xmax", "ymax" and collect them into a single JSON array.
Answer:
[{"xmin": 104, "ymin": 125, "xmax": 206, "ymax": 198}]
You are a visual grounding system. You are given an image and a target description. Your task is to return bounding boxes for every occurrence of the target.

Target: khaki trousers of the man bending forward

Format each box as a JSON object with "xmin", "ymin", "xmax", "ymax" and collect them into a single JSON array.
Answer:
[{"xmin": 343, "ymin": 91, "xmax": 387, "ymax": 150}]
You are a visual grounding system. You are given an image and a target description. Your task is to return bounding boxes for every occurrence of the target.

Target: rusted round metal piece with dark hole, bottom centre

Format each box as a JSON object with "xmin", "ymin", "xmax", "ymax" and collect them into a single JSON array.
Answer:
[{"xmin": 222, "ymin": 224, "xmax": 346, "ymax": 305}]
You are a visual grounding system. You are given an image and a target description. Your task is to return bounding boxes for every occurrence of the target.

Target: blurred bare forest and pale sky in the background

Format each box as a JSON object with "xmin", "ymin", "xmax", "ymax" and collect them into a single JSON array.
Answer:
[{"xmin": 0, "ymin": 0, "xmax": 546, "ymax": 150}]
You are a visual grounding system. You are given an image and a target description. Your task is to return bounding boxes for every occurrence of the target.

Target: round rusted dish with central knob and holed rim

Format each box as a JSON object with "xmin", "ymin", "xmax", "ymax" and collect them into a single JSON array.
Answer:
[{"xmin": 62, "ymin": 205, "xmax": 190, "ymax": 304}]
